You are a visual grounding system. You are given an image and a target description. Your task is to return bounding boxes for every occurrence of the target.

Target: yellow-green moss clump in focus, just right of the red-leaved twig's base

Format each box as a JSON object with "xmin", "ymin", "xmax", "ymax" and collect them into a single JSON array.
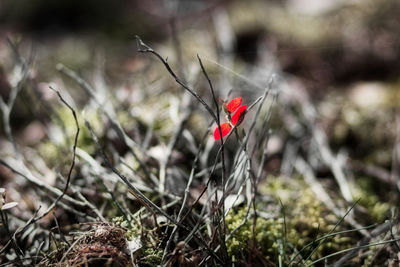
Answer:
[{"xmin": 261, "ymin": 177, "xmax": 351, "ymax": 260}]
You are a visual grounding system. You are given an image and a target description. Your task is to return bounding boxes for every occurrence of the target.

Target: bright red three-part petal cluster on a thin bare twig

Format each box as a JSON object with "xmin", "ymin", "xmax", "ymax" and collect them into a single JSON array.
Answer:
[{"xmin": 214, "ymin": 97, "xmax": 247, "ymax": 140}]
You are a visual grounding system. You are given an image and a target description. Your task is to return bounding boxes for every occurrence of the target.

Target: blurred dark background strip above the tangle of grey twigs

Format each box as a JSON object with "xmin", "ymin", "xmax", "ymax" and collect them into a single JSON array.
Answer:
[{"xmin": 0, "ymin": 0, "xmax": 400, "ymax": 90}]
